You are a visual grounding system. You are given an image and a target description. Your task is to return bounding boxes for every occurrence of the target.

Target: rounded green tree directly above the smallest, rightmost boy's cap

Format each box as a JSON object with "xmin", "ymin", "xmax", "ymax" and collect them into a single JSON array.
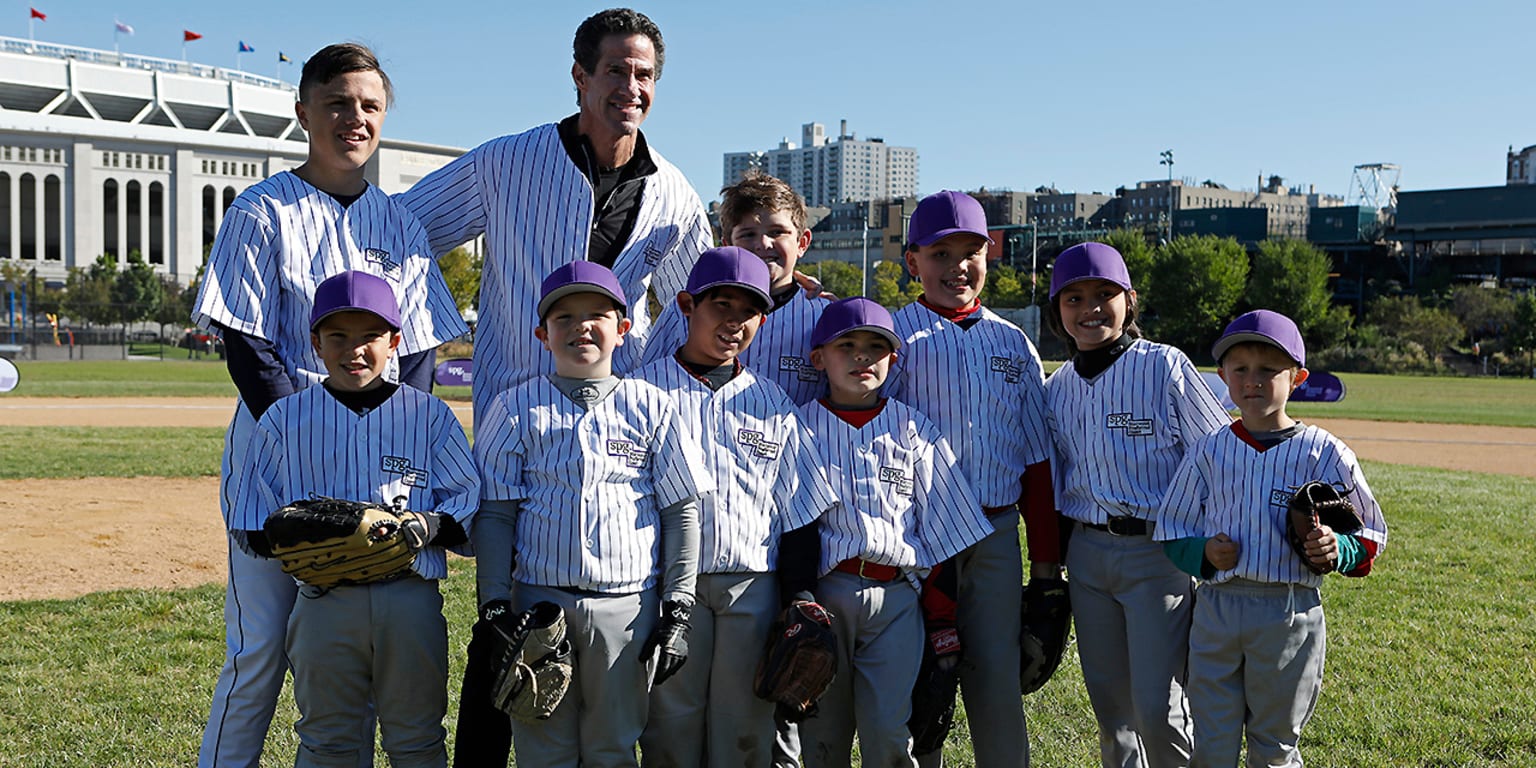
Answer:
[{"xmin": 1243, "ymin": 240, "xmax": 1333, "ymax": 339}]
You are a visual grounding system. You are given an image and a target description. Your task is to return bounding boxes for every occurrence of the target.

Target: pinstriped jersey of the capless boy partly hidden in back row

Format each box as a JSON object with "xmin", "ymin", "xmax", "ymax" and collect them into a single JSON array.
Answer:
[{"xmin": 645, "ymin": 289, "xmax": 831, "ymax": 406}]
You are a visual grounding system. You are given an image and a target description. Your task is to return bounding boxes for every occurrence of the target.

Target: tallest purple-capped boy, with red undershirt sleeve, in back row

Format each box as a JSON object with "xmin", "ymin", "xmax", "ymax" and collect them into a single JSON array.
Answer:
[{"xmin": 886, "ymin": 190, "xmax": 1061, "ymax": 768}]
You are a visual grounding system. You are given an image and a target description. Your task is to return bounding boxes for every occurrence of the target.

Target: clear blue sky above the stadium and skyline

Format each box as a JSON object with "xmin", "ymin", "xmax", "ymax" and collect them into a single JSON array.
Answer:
[{"xmin": 14, "ymin": 0, "xmax": 1536, "ymax": 200}]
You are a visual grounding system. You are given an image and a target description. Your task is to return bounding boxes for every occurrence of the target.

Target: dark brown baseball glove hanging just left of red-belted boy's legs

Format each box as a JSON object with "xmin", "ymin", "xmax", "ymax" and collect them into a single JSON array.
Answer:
[{"xmin": 753, "ymin": 601, "xmax": 837, "ymax": 722}]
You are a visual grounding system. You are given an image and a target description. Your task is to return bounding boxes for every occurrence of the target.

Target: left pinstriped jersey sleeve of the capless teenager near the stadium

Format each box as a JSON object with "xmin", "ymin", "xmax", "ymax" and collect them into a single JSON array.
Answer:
[{"xmin": 192, "ymin": 197, "xmax": 283, "ymax": 341}]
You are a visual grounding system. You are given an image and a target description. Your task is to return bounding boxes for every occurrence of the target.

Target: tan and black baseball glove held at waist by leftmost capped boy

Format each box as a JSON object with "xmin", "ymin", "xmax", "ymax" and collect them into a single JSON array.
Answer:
[{"xmin": 263, "ymin": 498, "xmax": 421, "ymax": 588}]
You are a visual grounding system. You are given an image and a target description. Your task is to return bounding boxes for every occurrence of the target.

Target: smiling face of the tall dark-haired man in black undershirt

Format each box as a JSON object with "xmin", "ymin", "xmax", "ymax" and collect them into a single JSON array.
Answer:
[{"xmin": 571, "ymin": 35, "xmax": 656, "ymax": 152}]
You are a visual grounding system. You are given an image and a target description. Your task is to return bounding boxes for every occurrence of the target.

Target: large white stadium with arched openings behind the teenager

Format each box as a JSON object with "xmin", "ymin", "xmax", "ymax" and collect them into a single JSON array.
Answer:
[{"xmin": 0, "ymin": 37, "xmax": 462, "ymax": 284}]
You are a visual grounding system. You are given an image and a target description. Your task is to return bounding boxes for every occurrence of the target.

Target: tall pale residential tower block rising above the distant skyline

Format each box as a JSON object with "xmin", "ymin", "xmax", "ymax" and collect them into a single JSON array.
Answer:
[{"xmin": 722, "ymin": 120, "xmax": 917, "ymax": 207}]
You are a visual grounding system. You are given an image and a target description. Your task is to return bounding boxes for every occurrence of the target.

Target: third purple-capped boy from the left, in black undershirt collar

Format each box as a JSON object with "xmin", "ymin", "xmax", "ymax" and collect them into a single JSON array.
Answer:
[{"xmin": 633, "ymin": 246, "xmax": 836, "ymax": 768}]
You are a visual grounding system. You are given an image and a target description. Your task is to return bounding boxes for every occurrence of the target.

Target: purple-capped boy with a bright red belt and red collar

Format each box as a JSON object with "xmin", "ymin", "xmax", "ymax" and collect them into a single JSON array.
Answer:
[{"xmin": 800, "ymin": 298, "xmax": 995, "ymax": 768}]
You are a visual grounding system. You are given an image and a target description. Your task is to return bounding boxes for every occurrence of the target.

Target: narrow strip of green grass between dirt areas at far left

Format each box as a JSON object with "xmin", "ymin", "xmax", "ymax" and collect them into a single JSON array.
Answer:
[{"xmin": 0, "ymin": 427, "xmax": 224, "ymax": 479}]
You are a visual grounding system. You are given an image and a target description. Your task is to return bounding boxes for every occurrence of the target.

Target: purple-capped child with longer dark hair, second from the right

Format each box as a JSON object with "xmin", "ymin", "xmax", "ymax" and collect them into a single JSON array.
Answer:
[{"xmin": 1046, "ymin": 243, "xmax": 1230, "ymax": 768}]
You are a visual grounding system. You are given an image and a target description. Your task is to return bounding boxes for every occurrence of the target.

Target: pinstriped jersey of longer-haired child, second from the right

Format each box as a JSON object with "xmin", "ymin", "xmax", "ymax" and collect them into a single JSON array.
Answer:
[{"xmin": 1046, "ymin": 339, "xmax": 1232, "ymax": 524}]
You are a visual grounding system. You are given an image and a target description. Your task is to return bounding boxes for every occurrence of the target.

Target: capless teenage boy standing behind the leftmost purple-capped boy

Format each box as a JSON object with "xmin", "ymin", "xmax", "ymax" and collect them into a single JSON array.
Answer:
[{"xmin": 192, "ymin": 43, "xmax": 468, "ymax": 768}]
